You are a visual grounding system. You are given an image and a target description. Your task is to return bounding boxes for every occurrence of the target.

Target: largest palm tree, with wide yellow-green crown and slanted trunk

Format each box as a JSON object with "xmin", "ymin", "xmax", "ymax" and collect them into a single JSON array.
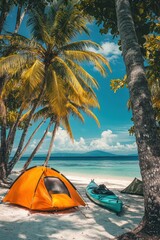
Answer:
[{"xmin": 0, "ymin": 4, "xmax": 109, "ymax": 180}]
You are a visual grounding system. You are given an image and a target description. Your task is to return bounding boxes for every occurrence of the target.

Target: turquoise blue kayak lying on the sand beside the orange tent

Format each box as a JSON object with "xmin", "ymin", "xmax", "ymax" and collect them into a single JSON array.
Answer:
[{"xmin": 86, "ymin": 180, "xmax": 123, "ymax": 213}]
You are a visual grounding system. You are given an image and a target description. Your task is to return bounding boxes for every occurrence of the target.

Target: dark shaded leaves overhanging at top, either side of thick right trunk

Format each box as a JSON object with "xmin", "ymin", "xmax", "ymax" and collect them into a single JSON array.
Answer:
[{"xmin": 80, "ymin": 0, "xmax": 160, "ymax": 46}]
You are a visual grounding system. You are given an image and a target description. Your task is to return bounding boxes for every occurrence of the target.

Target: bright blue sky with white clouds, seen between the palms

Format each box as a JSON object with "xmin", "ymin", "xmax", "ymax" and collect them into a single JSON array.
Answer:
[{"xmin": 6, "ymin": 8, "xmax": 137, "ymax": 154}]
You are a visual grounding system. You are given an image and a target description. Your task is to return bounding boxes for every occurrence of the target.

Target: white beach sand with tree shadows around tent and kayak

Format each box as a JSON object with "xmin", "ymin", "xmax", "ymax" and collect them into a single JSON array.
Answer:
[{"xmin": 0, "ymin": 175, "xmax": 143, "ymax": 240}]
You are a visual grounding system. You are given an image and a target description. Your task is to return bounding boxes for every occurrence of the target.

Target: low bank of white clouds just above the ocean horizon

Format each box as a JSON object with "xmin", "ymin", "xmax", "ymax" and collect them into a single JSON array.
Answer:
[{"xmin": 31, "ymin": 127, "xmax": 137, "ymax": 154}]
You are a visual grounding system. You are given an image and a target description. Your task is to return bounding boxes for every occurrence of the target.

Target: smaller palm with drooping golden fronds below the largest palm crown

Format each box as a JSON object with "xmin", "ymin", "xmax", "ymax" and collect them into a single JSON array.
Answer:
[{"xmin": 23, "ymin": 77, "xmax": 100, "ymax": 171}]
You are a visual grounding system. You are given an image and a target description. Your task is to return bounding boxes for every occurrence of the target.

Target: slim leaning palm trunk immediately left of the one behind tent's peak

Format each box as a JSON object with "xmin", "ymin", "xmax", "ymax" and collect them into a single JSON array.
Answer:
[{"xmin": 22, "ymin": 121, "xmax": 52, "ymax": 172}]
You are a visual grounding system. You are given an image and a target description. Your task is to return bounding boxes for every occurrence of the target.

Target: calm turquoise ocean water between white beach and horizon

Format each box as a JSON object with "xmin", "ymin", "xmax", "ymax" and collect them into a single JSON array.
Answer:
[{"xmin": 14, "ymin": 156, "xmax": 140, "ymax": 178}]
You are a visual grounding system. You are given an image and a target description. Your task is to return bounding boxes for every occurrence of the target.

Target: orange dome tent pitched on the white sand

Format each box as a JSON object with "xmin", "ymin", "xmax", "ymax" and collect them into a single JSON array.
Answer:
[{"xmin": 2, "ymin": 166, "xmax": 85, "ymax": 210}]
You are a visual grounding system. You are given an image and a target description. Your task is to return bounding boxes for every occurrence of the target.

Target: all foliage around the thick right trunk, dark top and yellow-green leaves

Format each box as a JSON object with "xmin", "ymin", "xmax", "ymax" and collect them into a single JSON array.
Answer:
[{"xmin": 81, "ymin": 0, "xmax": 160, "ymax": 134}]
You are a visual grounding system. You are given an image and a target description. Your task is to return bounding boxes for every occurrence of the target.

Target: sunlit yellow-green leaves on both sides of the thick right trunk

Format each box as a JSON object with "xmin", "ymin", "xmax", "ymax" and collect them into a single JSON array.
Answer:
[{"xmin": 110, "ymin": 34, "xmax": 160, "ymax": 134}]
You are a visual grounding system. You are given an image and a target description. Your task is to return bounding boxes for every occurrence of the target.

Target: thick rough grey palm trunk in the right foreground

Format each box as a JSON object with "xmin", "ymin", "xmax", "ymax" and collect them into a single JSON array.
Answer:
[{"xmin": 115, "ymin": 0, "xmax": 160, "ymax": 236}]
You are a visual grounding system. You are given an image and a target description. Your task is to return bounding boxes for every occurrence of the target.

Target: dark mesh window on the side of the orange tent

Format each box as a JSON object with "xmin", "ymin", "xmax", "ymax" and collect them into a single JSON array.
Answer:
[{"xmin": 44, "ymin": 177, "xmax": 70, "ymax": 197}]
